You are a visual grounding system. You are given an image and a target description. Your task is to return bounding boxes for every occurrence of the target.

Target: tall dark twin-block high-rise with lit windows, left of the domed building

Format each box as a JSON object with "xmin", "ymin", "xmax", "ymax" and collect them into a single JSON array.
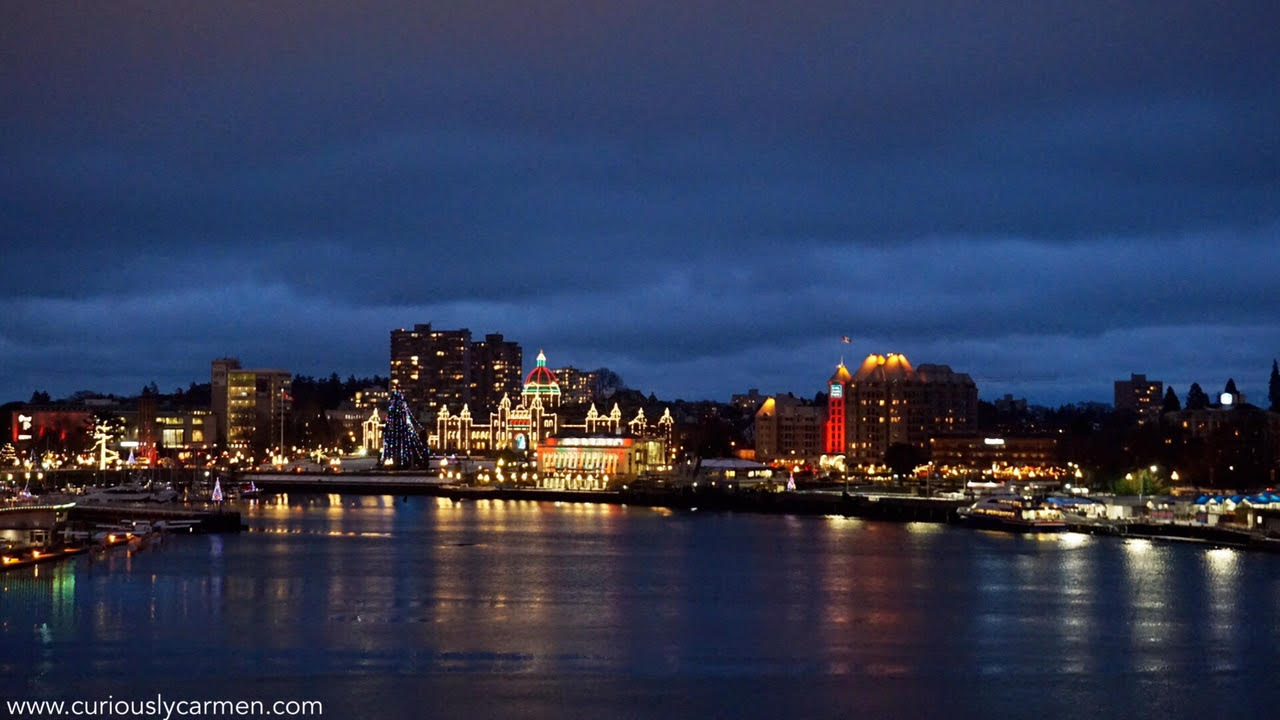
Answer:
[{"xmin": 390, "ymin": 323, "xmax": 524, "ymax": 421}]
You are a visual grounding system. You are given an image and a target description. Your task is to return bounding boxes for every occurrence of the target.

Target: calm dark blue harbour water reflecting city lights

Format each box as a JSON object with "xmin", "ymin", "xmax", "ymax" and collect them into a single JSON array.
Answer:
[{"xmin": 0, "ymin": 496, "xmax": 1280, "ymax": 717}]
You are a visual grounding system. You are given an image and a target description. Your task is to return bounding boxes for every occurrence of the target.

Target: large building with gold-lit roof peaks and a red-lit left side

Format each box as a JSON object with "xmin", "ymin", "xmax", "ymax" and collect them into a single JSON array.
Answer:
[{"xmin": 823, "ymin": 354, "xmax": 978, "ymax": 465}]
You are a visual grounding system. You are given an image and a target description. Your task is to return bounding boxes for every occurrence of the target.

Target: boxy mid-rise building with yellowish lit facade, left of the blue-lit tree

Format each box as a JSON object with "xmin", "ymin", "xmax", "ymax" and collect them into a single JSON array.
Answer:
[{"xmin": 210, "ymin": 357, "xmax": 293, "ymax": 450}]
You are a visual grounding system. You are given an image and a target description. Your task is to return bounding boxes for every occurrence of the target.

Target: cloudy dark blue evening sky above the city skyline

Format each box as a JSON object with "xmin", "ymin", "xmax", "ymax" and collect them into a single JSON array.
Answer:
[{"xmin": 0, "ymin": 0, "xmax": 1280, "ymax": 404}]
